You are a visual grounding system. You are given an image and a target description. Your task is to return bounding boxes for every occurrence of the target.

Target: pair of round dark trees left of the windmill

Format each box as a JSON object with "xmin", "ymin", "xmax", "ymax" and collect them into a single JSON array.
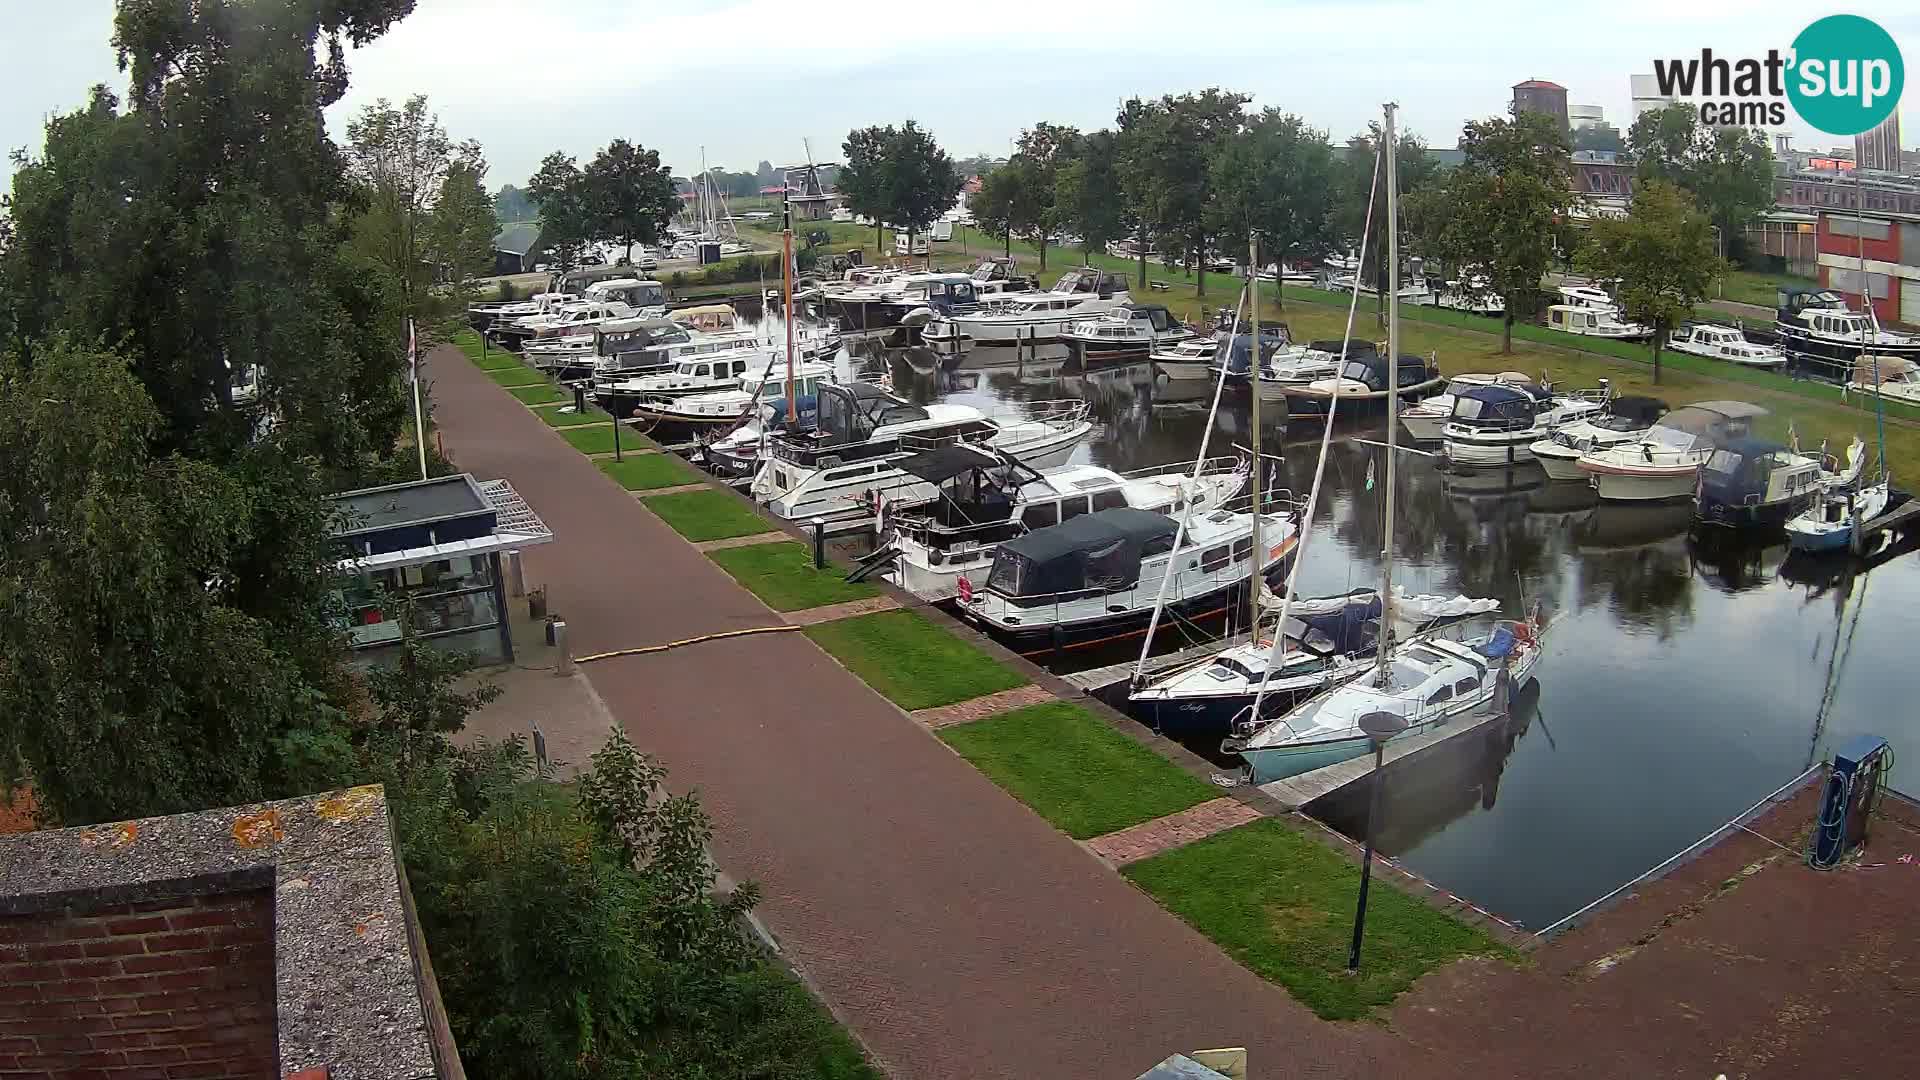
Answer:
[{"xmin": 526, "ymin": 138, "xmax": 680, "ymax": 263}]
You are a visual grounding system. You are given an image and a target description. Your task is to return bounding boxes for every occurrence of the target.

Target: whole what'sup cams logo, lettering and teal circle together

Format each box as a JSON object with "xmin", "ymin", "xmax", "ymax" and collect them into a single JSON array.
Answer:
[{"xmin": 1653, "ymin": 15, "xmax": 1907, "ymax": 135}]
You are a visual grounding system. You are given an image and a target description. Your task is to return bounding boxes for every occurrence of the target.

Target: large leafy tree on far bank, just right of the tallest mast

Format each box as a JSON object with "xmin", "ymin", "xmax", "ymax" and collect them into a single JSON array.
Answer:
[{"xmin": 1415, "ymin": 111, "xmax": 1574, "ymax": 352}]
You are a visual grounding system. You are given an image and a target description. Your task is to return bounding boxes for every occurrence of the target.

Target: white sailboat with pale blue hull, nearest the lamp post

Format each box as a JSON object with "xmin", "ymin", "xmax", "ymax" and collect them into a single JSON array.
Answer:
[{"xmin": 1221, "ymin": 619, "xmax": 1540, "ymax": 784}]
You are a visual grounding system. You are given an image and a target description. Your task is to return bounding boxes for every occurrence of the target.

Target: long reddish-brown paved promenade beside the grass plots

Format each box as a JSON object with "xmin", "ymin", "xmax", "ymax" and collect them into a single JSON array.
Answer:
[{"xmin": 432, "ymin": 348, "xmax": 1405, "ymax": 1080}]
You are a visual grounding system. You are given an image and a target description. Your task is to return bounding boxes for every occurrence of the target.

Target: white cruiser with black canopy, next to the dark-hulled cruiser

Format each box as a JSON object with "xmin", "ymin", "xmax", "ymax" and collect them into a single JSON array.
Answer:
[{"xmin": 876, "ymin": 444, "xmax": 1248, "ymax": 600}]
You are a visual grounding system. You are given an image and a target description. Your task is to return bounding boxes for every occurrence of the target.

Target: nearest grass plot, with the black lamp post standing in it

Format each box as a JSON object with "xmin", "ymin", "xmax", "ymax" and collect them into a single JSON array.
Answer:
[{"xmin": 1121, "ymin": 821, "xmax": 1515, "ymax": 1020}]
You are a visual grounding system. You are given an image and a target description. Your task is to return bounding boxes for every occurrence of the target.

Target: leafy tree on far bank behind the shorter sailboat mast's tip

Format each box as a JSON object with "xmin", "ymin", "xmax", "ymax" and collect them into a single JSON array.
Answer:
[{"xmin": 1210, "ymin": 108, "xmax": 1334, "ymax": 305}]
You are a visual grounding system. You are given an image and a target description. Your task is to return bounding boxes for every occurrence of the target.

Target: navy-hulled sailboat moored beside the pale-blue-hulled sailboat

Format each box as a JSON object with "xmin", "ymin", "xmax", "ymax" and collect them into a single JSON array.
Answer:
[{"xmin": 1127, "ymin": 588, "xmax": 1500, "ymax": 736}]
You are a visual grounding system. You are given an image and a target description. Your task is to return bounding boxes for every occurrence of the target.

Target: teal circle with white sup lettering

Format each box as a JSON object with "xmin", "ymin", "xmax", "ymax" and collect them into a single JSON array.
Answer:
[{"xmin": 1788, "ymin": 15, "xmax": 1907, "ymax": 135}]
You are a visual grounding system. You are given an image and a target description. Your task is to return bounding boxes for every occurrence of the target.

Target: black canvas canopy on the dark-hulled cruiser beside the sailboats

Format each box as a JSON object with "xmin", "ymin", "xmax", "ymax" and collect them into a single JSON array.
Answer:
[{"xmin": 987, "ymin": 507, "xmax": 1179, "ymax": 605}]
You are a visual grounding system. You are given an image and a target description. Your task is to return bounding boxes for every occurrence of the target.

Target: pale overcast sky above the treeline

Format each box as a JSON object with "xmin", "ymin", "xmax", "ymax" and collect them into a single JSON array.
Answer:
[{"xmin": 0, "ymin": 0, "xmax": 1920, "ymax": 186}]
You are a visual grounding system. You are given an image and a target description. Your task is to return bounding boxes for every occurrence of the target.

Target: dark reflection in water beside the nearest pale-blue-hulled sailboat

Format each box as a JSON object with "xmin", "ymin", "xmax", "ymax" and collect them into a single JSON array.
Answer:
[{"xmin": 1306, "ymin": 678, "xmax": 1546, "ymax": 857}]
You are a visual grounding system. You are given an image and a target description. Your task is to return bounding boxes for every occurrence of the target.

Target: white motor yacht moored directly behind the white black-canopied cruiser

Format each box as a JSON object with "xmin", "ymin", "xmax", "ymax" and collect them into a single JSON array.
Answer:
[{"xmin": 753, "ymin": 382, "xmax": 1092, "ymax": 521}]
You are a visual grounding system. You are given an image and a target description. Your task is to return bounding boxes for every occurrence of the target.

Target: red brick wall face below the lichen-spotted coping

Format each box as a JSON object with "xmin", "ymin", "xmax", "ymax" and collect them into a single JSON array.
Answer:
[{"xmin": 0, "ymin": 890, "xmax": 278, "ymax": 1080}]
